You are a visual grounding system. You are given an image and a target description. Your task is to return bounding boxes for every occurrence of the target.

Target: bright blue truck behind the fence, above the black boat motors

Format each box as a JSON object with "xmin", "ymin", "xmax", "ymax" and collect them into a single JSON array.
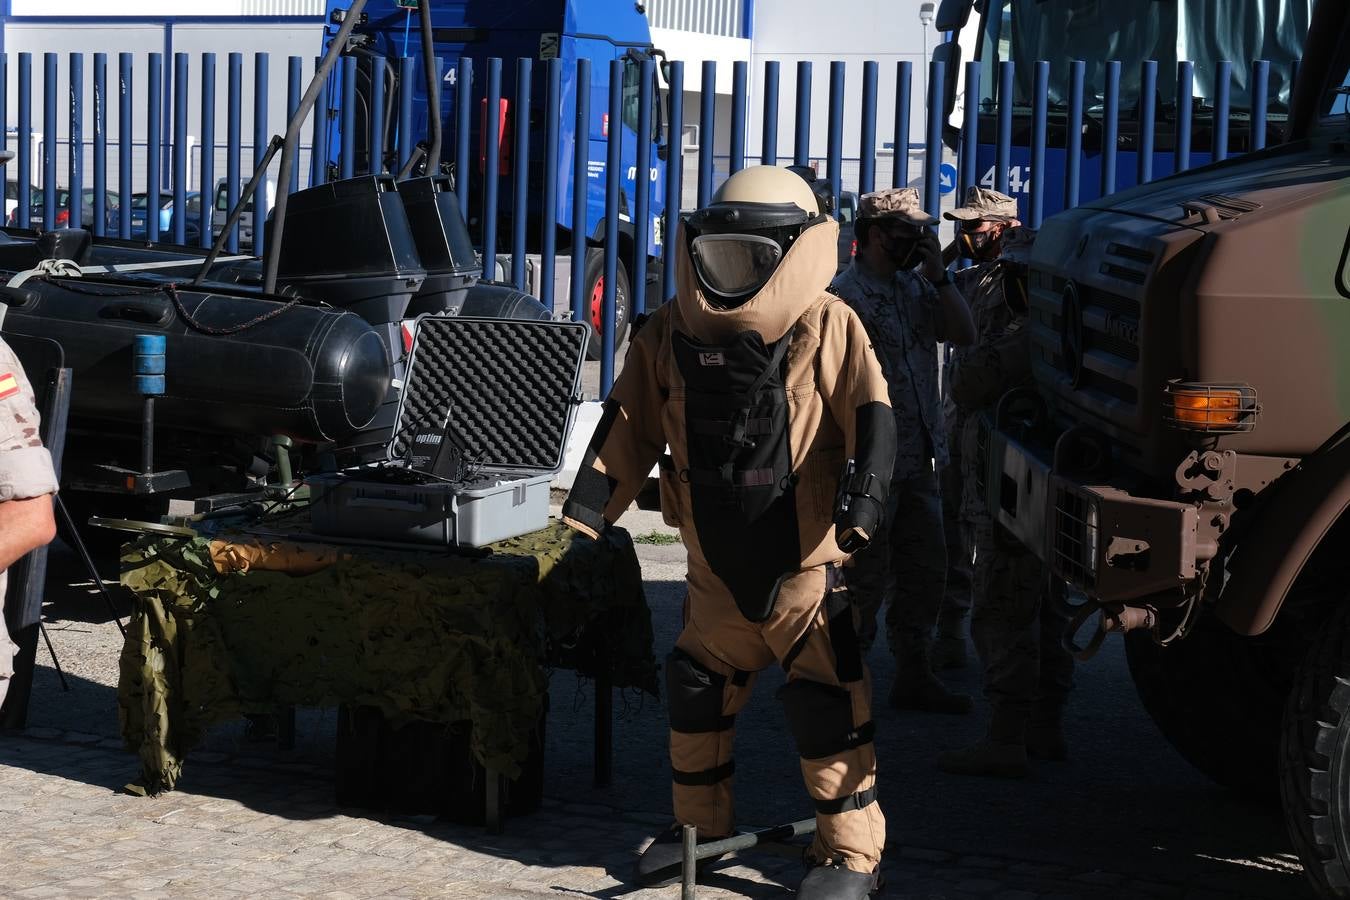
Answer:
[{"xmin": 320, "ymin": 0, "xmax": 670, "ymax": 349}]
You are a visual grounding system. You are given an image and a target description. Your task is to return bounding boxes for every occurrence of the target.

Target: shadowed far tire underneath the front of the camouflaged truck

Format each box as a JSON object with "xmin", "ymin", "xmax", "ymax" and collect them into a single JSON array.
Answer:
[{"xmin": 1125, "ymin": 611, "xmax": 1297, "ymax": 803}]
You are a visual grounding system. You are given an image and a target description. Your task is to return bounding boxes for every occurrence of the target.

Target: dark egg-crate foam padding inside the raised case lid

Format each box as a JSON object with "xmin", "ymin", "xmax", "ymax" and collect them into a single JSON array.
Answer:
[{"xmin": 390, "ymin": 316, "xmax": 590, "ymax": 472}]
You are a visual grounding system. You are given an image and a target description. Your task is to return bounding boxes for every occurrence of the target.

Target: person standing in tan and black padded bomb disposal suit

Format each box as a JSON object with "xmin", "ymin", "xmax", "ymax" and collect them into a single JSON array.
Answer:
[{"xmin": 563, "ymin": 166, "xmax": 895, "ymax": 900}]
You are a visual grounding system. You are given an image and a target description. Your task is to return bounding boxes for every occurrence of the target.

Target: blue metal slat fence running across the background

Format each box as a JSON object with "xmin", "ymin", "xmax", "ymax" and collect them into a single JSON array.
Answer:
[{"xmin": 0, "ymin": 53, "xmax": 1296, "ymax": 391}]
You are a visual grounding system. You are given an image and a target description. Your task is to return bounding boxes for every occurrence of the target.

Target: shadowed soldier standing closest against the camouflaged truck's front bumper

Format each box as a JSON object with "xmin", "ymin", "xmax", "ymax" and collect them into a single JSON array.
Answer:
[{"xmin": 938, "ymin": 228, "xmax": 1073, "ymax": 777}]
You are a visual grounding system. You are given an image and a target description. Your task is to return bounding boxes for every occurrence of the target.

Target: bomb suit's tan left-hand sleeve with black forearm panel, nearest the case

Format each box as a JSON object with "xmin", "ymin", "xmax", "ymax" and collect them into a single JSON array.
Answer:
[{"xmin": 563, "ymin": 305, "xmax": 671, "ymax": 537}]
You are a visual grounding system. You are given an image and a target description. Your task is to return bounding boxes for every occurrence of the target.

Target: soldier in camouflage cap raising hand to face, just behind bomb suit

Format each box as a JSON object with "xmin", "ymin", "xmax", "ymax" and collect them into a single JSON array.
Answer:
[{"xmin": 830, "ymin": 188, "xmax": 975, "ymax": 714}]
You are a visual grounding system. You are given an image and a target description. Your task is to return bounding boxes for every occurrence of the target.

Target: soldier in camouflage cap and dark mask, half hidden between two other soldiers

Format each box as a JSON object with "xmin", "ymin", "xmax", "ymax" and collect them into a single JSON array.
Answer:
[{"xmin": 933, "ymin": 185, "xmax": 1019, "ymax": 669}]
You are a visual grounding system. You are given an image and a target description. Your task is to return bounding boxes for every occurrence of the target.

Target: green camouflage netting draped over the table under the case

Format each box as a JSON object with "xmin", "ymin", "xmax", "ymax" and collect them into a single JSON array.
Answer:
[{"xmin": 117, "ymin": 522, "xmax": 657, "ymax": 793}]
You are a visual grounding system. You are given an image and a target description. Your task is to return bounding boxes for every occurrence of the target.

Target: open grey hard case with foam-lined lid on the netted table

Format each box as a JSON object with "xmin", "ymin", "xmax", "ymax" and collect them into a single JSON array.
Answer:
[{"xmin": 309, "ymin": 316, "xmax": 589, "ymax": 546}]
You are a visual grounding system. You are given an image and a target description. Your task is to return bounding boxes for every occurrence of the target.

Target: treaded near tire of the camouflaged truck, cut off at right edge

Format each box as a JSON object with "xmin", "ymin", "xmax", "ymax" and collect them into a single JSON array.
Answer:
[{"xmin": 1280, "ymin": 609, "xmax": 1350, "ymax": 897}]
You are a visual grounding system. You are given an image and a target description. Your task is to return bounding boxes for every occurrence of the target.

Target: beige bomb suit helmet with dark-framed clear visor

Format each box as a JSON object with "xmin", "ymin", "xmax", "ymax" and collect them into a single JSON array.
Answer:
[{"xmin": 684, "ymin": 166, "xmax": 829, "ymax": 309}]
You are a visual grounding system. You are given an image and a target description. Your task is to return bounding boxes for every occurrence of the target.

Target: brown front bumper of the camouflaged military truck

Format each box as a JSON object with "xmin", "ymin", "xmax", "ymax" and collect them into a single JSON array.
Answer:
[{"xmin": 981, "ymin": 428, "xmax": 1202, "ymax": 603}]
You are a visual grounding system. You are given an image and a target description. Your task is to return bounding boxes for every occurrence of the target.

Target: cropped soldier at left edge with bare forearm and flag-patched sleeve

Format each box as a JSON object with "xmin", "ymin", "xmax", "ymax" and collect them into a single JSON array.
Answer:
[{"xmin": 0, "ymin": 334, "xmax": 57, "ymax": 703}]
